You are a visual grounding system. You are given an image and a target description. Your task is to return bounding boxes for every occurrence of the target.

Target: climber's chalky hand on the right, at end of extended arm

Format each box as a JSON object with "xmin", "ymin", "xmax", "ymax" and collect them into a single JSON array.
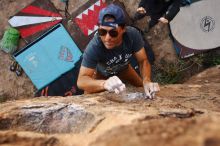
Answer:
[{"xmin": 144, "ymin": 82, "xmax": 160, "ymax": 99}]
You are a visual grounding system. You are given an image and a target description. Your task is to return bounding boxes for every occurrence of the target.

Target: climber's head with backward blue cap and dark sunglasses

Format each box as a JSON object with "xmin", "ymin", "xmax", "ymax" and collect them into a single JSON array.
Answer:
[{"xmin": 98, "ymin": 4, "xmax": 125, "ymax": 49}]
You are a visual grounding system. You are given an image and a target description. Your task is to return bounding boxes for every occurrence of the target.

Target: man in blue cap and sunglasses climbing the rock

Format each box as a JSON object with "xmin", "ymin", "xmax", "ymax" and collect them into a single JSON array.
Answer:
[{"xmin": 77, "ymin": 4, "xmax": 159, "ymax": 98}]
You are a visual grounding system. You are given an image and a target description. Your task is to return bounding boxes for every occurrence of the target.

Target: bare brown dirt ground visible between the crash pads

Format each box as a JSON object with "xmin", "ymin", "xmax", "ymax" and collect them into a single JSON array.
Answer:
[{"xmin": 0, "ymin": 0, "xmax": 176, "ymax": 101}]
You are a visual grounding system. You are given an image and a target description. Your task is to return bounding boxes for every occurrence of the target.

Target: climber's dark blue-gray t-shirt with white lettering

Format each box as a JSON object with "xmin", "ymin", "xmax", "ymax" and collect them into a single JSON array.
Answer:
[{"xmin": 82, "ymin": 26, "xmax": 144, "ymax": 77}]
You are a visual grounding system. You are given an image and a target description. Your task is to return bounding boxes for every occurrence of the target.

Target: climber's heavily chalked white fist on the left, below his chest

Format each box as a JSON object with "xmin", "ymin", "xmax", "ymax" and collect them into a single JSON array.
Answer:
[{"xmin": 103, "ymin": 76, "xmax": 125, "ymax": 94}]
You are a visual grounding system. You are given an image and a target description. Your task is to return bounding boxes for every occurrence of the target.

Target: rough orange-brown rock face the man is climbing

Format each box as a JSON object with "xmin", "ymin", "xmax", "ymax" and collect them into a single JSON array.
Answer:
[{"xmin": 0, "ymin": 66, "xmax": 220, "ymax": 146}]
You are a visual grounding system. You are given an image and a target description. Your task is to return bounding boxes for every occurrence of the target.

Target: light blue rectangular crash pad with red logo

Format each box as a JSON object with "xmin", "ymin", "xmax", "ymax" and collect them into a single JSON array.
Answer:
[{"xmin": 14, "ymin": 24, "xmax": 82, "ymax": 89}]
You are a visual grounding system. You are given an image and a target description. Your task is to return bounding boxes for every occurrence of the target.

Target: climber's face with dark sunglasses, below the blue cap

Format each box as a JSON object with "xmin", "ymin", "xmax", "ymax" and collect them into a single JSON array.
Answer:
[{"xmin": 98, "ymin": 25, "xmax": 125, "ymax": 49}]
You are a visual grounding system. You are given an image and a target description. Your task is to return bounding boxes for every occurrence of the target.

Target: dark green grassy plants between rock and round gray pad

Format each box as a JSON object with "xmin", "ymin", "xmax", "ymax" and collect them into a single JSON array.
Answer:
[{"xmin": 152, "ymin": 51, "xmax": 220, "ymax": 84}]
